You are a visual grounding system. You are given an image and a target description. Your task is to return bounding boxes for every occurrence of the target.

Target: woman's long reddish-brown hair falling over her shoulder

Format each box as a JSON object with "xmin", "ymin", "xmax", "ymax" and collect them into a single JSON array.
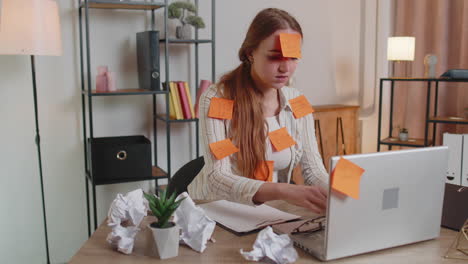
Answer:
[{"xmin": 219, "ymin": 8, "xmax": 302, "ymax": 178}]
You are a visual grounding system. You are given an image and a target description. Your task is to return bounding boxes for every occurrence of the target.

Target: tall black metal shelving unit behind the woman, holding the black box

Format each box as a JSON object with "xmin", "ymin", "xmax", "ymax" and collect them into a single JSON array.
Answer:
[{"xmin": 78, "ymin": 0, "xmax": 216, "ymax": 236}]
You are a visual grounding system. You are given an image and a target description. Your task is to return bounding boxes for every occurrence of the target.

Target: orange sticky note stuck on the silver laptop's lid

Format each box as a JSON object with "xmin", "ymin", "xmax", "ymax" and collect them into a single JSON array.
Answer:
[{"xmin": 331, "ymin": 158, "xmax": 364, "ymax": 200}]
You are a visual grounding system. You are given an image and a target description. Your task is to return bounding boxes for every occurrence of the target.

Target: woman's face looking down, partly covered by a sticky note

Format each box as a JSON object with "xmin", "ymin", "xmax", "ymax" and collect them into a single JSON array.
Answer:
[{"xmin": 251, "ymin": 29, "xmax": 299, "ymax": 89}]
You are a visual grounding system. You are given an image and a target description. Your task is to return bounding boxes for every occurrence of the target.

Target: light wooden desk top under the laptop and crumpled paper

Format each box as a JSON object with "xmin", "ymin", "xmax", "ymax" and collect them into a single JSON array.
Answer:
[{"xmin": 70, "ymin": 201, "xmax": 467, "ymax": 264}]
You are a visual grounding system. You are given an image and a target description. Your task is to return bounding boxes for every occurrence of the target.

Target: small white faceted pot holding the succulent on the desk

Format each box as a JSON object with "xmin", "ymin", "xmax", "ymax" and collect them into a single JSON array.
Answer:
[{"xmin": 148, "ymin": 224, "xmax": 180, "ymax": 259}]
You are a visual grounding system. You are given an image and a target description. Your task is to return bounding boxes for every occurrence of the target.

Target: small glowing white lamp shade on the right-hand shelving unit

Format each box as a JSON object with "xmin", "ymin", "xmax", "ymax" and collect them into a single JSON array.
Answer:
[{"xmin": 387, "ymin": 37, "xmax": 416, "ymax": 61}]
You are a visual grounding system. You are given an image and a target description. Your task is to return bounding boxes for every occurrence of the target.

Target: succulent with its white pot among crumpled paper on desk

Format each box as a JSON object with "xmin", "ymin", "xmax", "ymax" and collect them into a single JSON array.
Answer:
[{"xmin": 144, "ymin": 190, "xmax": 185, "ymax": 259}]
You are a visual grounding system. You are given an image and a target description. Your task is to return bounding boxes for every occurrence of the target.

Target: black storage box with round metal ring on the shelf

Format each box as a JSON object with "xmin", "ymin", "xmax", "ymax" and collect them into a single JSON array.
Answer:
[{"xmin": 88, "ymin": 136, "xmax": 151, "ymax": 184}]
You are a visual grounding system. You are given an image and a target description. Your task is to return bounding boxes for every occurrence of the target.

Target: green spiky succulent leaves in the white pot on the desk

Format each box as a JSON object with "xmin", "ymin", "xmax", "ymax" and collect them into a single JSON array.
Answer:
[{"xmin": 143, "ymin": 190, "xmax": 185, "ymax": 228}]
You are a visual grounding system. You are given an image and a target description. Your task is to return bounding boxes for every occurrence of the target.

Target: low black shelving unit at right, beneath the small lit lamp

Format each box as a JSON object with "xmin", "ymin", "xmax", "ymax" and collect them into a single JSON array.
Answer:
[{"xmin": 377, "ymin": 78, "xmax": 468, "ymax": 151}]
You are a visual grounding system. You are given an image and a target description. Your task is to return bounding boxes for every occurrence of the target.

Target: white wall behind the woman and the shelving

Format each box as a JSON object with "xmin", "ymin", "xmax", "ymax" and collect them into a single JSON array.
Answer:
[{"xmin": 0, "ymin": 0, "xmax": 389, "ymax": 263}]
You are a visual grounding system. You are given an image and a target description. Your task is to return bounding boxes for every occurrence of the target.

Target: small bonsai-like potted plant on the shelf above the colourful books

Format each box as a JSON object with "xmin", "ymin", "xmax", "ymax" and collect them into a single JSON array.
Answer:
[{"xmin": 168, "ymin": 1, "xmax": 205, "ymax": 39}]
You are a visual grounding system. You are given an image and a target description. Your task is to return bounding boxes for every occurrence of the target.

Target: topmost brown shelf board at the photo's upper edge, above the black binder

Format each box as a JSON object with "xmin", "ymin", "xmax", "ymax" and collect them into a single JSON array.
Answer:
[{"xmin": 80, "ymin": 0, "xmax": 165, "ymax": 10}]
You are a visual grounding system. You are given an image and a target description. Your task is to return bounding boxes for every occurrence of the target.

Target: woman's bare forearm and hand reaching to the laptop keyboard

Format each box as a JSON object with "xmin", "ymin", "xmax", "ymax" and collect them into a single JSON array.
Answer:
[{"xmin": 253, "ymin": 183, "xmax": 327, "ymax": 214}]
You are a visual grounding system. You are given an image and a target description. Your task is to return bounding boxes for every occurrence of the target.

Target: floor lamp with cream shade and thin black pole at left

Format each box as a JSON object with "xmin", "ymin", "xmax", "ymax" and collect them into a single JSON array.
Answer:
[{"xmin": 0, "ymin": 0, "xmax": 62, "ymax": 263}]
